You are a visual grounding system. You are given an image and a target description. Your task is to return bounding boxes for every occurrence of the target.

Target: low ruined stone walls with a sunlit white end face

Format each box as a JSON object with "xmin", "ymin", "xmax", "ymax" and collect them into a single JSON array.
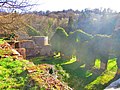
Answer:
[{"xmin": 8, "ymin": 36, "xmax": 53, "ymax": 58}]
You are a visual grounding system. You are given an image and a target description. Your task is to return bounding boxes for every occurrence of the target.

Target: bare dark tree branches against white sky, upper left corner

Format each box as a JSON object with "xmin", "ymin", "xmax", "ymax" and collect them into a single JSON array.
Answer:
[{"xmin": 0, "ymin": 0, "xmax": 37, "ymax": 12}]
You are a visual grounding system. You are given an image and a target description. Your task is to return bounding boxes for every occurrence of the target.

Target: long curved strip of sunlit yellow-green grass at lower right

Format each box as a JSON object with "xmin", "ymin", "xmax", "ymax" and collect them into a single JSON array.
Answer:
[{"xmin": 85, "ymin": 58, "xmax": 117, "ymax": 90}]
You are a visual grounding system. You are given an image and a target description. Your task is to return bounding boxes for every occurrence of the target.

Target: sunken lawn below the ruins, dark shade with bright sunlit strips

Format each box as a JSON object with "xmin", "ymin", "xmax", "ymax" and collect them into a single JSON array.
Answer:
[{"xmin": 31, "ymin": 57, "xmax": 117, "ymax": 90}]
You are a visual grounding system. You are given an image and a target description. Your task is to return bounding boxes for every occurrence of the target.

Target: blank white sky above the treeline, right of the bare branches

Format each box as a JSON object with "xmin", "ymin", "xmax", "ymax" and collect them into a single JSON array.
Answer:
[{"xmin": 33, "ymin": 0, "xmax": 120, "ymax": 12}]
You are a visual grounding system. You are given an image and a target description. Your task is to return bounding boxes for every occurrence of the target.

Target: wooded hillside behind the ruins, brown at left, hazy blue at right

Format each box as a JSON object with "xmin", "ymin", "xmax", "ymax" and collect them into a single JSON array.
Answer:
[{"xmin": 0, "ymin": 8, "xmax": 120, "ymax": 38}]
